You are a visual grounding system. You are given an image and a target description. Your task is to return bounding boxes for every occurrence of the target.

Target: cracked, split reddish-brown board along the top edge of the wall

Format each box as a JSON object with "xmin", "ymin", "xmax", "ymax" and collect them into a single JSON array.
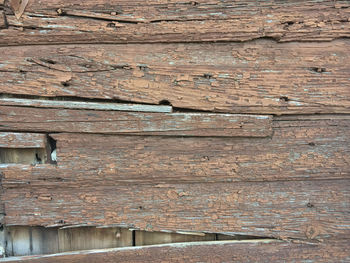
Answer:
[{"xmin": 0, "ymin": 0, "xmax": 350, "ymax": 45}]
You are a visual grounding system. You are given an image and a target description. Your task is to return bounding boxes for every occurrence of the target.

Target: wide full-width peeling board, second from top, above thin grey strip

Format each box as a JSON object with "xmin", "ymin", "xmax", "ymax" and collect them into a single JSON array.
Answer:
[{"xmin": 0, "ymin": 40, "xmax": 350, "ymax": 114}]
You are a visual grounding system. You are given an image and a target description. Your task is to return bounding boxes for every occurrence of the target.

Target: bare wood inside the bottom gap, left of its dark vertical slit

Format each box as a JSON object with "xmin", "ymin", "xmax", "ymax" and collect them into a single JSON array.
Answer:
[{"xmin": 5, "ymin": 226, "xmax": 133, "ymax": 256}]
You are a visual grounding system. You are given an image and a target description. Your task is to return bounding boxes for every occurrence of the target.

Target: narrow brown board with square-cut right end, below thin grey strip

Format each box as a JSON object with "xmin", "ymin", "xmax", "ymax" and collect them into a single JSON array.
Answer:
[{"xmin": 0, "ymin": 105, "xmax": 272, "ymax": 137}]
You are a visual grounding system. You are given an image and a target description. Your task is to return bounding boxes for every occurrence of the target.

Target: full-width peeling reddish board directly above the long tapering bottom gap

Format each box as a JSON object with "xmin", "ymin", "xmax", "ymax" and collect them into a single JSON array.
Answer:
[{"xmin": 3, "ymin": 179, "xmax": 350, "ymax": 241}]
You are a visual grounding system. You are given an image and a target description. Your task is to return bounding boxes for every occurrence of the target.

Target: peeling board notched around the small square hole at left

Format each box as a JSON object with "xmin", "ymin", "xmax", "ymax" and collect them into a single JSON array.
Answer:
[{"xmin": 1, "ymin": 114, "xmax": 350, "ymax": 186}]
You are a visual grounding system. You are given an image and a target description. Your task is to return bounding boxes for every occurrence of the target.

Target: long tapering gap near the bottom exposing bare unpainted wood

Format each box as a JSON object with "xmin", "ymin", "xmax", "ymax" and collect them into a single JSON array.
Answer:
[{"xmin": 0, "ymin": 226, "xmax": 280, "ymax": 257}]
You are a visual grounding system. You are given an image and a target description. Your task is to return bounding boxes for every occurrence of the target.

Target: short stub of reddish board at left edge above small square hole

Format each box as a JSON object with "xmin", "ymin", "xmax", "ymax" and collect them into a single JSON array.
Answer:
[{"xmin": 0, "ymin": 132, "xmax": 47, "ymax": 148}]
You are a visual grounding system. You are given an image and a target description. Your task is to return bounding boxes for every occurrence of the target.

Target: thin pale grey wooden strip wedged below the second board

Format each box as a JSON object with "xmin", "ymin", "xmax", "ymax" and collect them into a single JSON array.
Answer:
[{"xmin": 0, "ymin": 98, "xmax": 172, "ymax": 113}]
